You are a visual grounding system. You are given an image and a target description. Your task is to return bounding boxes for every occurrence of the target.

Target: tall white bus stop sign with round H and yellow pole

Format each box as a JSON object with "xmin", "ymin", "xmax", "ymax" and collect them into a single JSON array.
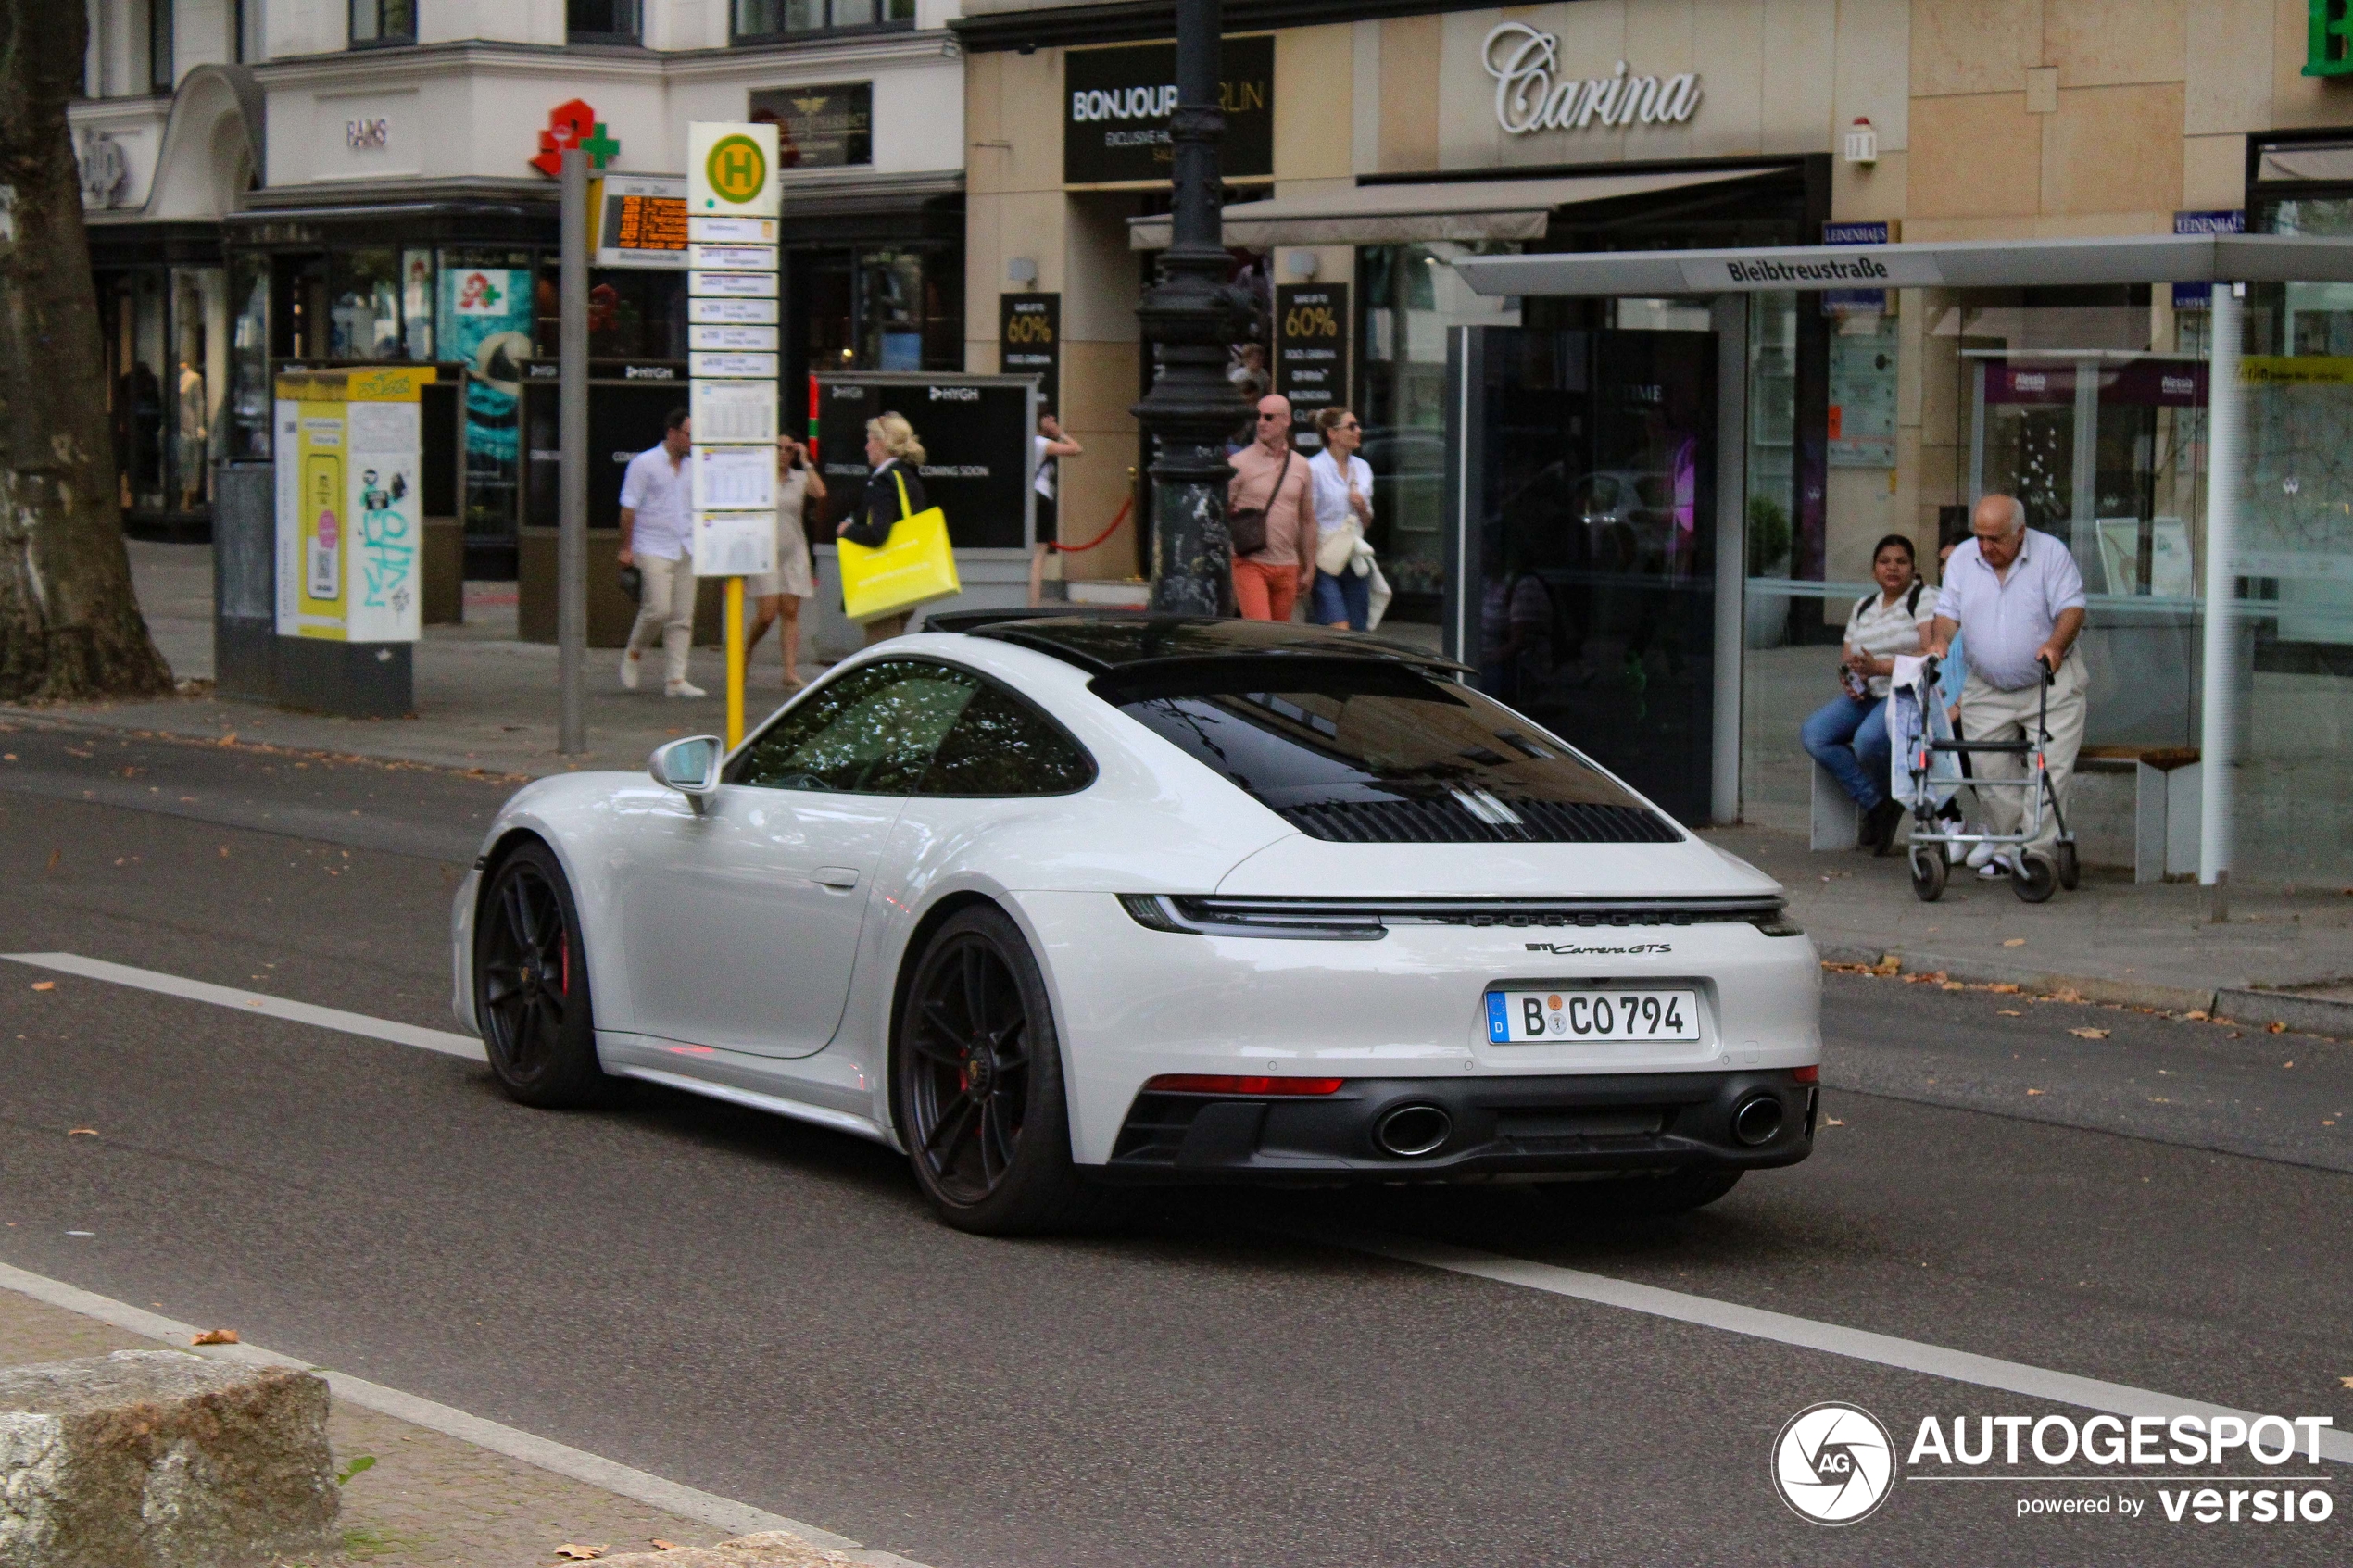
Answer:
[{"xmin": 687, "ymin": 119, "xmax": 779, "ymax": 747}]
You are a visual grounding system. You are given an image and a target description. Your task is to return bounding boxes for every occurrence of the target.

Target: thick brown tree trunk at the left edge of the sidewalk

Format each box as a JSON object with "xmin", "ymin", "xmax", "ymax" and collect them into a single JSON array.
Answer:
[{"xmin": 0, "ymin": 0, "xmax": 171, "ymax": 700}]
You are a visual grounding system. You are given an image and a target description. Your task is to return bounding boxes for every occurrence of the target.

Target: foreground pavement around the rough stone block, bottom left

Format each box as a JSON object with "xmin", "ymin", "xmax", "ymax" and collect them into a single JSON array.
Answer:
[{"xmin": 0, "ymin": 1270, "xmax": 918, "ymax": 1568}]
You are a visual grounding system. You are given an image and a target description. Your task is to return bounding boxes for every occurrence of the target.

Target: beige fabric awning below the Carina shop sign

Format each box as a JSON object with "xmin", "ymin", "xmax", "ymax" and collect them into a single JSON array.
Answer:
[{"xmin": 1127, "ymin": 169, "xmax": 1774, "ymax": 252}]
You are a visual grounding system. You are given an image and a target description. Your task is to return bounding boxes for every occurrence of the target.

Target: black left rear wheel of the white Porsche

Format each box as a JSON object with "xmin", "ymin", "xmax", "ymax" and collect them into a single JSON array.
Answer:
[{"xmin": 892, "ymin": 905, "xmax": 1111, "ymax": 1236}]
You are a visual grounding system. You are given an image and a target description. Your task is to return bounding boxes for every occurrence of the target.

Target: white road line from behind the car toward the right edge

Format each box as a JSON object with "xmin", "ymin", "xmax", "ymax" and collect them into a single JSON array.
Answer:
[{"xmin": 1322, "ymin": 1236, "xmax": 2353, "ymax": 1464}]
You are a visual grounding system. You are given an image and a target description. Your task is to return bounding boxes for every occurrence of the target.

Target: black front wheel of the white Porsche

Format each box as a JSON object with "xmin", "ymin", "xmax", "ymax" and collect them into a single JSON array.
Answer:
[{"xmin": 473, "ymin": 842, "xmax": 610, "ymax": 1110}]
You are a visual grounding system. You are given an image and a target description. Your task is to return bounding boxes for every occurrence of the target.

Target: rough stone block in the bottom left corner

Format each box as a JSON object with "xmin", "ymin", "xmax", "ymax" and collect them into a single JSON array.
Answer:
[{"xmin": 0, "ymin": 1349, "xmax": 339, "ymax": 1568}]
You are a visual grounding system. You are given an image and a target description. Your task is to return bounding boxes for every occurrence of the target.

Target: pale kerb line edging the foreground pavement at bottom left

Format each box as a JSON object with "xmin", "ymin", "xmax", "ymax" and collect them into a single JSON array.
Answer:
[{"xmin": 0, "ymin": 1260, "xmax": 923, "ymax": 1568}]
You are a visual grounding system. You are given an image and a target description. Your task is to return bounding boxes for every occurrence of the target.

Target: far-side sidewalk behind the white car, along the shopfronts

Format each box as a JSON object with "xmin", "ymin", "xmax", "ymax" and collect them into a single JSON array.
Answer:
[{"xmin": 18, "ymin": 543, "xmax": 2353, "ymax": 1039}]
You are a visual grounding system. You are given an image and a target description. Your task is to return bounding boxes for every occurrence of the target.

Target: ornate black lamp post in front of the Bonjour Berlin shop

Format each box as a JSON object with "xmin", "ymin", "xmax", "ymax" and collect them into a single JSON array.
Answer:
[{"xmin": 1134, "ymin": 0, "xmax": 1245, "ymax": 616}]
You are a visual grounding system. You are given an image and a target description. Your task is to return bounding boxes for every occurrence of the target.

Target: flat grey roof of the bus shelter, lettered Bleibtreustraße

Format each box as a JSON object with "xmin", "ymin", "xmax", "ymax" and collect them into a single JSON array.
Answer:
[{"xmin": 1454, "ymin": 235, "xmax": 2353, "ymax": 296}]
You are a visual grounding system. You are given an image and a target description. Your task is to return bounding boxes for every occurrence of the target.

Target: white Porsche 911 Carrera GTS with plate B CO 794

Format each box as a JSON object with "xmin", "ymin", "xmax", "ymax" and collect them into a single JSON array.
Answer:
[{"xmin": 452, "ymin": 611, "xmax": 1821, "ymax": 1235}]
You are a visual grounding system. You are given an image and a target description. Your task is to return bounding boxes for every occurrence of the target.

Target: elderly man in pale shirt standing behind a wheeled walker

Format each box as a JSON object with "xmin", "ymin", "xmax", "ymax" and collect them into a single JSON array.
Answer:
[{"xmin": 1930, "ymin": 496, "xmax": 2090, "ymax": 877}]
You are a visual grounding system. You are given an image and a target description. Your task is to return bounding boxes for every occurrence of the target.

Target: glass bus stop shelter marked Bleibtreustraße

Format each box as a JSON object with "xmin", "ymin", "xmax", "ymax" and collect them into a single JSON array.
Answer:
[{"xmin": 1445, "ymin": 235, "xmax": 2353, "ymax": 902}]
